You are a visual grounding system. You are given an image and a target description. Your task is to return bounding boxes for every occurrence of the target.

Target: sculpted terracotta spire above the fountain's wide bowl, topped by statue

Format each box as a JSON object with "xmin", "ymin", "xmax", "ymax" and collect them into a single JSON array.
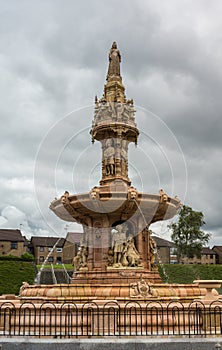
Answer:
[{"xmin": 91, "ymin": 42, "xmax": 139, "ymax": 185}]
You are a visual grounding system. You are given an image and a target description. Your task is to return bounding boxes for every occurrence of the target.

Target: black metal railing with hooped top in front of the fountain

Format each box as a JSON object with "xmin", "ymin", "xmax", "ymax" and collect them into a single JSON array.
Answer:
[{"xmin": 0, "ymin": 300, "xmax": 222, "ymax": 338}]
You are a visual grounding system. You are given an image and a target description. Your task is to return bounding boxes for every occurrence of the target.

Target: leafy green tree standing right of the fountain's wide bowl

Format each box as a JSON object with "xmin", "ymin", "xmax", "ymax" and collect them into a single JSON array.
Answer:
[{"xmin": 168, "ymin": 205, "xmax": 210, "ymax": 262}]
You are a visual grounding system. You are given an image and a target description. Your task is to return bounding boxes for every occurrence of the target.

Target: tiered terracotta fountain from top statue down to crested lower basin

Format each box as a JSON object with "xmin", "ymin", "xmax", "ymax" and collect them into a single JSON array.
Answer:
[{"xmin": 20, "ymin": 42, "xmax": 219, "ymax": 302}]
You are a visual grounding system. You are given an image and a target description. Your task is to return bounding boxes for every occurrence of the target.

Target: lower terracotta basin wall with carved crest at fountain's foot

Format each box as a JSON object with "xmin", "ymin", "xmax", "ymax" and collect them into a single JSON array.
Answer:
[{"xmin": 20, "ymin": 279, "xmax": 207, "ymax": 303}]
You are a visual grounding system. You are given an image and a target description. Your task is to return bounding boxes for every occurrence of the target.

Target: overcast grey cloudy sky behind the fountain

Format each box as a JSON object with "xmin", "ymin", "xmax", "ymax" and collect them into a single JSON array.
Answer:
[{"xmin": 0, "ymin": 0, "xmax": 222, "ymax": 245}]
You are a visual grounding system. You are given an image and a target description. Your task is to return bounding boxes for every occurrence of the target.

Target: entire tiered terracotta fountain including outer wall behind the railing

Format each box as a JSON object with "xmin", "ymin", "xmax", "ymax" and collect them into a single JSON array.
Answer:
[{"xmin": 0, "ymin": 42, "xmax": 221, "ymax": 337}]
